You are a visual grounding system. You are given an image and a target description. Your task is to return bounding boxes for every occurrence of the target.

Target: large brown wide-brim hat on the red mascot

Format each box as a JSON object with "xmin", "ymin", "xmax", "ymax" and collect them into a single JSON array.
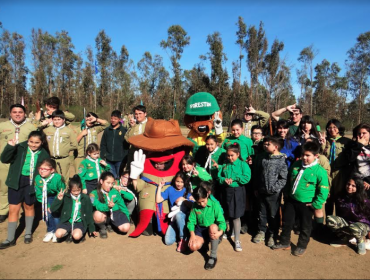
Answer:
[{"xmin": 128, "ymin": 118, "xmax": 194, "ymax": 152}]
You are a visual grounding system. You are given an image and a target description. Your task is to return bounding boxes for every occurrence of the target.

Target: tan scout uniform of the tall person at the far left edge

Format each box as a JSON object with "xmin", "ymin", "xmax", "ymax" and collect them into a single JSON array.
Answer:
[{"xmin": 0, "ymin": 120, "xmax": 36, "ymax": 215}]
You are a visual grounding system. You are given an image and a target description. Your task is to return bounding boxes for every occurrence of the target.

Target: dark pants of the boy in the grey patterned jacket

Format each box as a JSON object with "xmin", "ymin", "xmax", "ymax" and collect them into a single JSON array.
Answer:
[{"xmin": 258, "ymin": 193, "xmax": 280, "ymax": 236}]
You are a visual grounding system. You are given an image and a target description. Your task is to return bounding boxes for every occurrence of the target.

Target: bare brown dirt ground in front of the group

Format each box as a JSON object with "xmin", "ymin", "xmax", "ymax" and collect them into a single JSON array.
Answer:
[{"xmin": 0, "ymin": 222, "xmax": 370, "ymax": 279}]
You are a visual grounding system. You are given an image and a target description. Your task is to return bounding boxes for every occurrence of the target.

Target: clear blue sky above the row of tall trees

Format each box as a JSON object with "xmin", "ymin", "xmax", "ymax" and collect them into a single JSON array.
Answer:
[{"xmin": 0, "ymin": 0, "xmax": 370, "ymax": 95}]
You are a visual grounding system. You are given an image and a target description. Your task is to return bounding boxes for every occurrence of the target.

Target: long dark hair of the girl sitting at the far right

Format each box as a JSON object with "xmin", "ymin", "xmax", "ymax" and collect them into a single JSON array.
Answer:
[{"xmin": 341, "ymin": 176, "xmax": 370, "ymax": 217}]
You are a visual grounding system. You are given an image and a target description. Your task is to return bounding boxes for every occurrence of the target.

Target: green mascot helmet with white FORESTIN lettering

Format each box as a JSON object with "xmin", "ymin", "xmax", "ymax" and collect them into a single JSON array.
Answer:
[{"xmin": 185, "ymin": 92, "xmax": 220, "ymax": 116}]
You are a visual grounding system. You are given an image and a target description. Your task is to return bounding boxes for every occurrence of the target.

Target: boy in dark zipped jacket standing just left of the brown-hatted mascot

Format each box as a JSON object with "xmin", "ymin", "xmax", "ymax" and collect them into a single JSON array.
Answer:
[{"xmin": 100, "ymin": 110, "xmax": 129, "ymax": 179}]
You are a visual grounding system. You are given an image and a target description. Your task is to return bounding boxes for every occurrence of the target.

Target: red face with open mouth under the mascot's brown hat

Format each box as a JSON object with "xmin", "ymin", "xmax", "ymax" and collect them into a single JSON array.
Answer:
[{"xmin": 144, "ymin": 147, "xmax": 189, "ymax": 177}]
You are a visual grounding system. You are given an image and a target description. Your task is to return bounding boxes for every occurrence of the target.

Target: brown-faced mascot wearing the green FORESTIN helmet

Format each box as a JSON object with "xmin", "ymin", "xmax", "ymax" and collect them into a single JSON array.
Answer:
[{"xmin": 184, "ymin": 92, "xmax": 226, "ymax": 155}]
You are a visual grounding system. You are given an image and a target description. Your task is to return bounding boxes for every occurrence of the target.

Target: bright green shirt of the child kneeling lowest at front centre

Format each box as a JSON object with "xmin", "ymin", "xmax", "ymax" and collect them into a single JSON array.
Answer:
[{"xmin": 187, "ymin": 199, "xmax": 226, "ymax": 237}]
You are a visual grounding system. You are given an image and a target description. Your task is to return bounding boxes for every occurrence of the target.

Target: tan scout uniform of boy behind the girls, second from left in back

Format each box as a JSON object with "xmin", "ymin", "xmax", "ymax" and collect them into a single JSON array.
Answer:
[{"xmin": 44, "ymin": 124, "xmax": 77, "ymax": 183}]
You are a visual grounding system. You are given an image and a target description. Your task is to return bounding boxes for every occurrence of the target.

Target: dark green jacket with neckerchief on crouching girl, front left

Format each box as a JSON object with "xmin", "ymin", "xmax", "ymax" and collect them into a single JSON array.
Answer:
[{"xmin": 50, "ymin": 193, "xmax": 95, "ymax": 234}]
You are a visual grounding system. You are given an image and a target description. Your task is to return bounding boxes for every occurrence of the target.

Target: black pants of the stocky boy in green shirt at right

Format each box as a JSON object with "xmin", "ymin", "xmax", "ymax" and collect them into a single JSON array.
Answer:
[{"xmin": 280, "ymin": 199, "xmax": 313, "ymax": 249}]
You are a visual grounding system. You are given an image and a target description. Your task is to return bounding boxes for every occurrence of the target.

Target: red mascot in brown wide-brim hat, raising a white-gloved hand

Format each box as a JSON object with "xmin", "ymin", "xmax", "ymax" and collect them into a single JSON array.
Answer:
[{"xmin": 129, "ymin": 118, "xmax": 194, "ymax": 237}]
